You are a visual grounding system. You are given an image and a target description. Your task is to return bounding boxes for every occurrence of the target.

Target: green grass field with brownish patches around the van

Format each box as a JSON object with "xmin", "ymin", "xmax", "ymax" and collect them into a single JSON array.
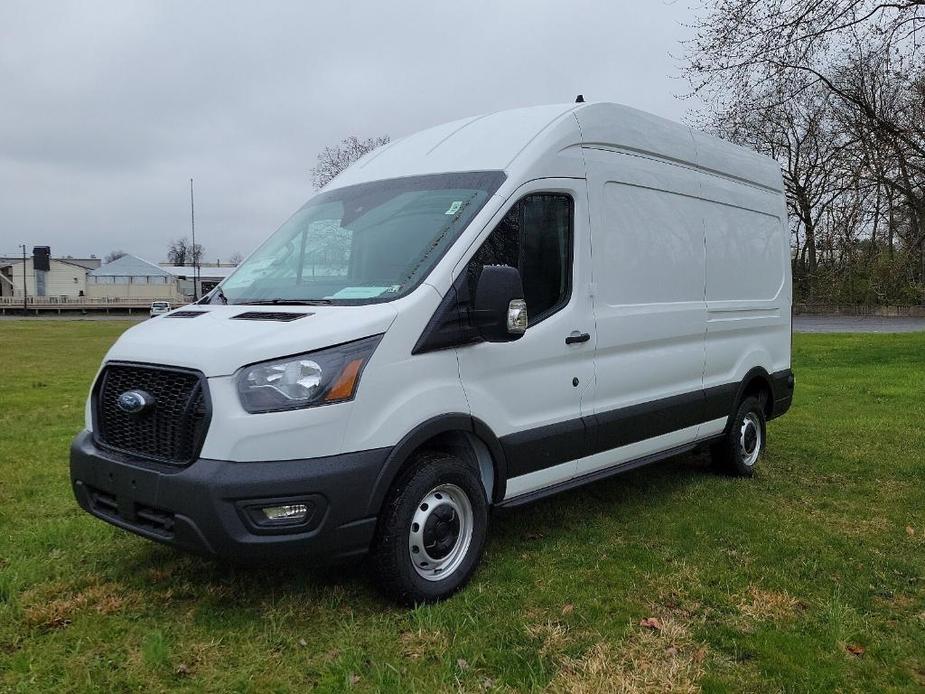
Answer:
[{"xmin": 0, "ymin": 321, "xmax": 925, "ymax": 692}]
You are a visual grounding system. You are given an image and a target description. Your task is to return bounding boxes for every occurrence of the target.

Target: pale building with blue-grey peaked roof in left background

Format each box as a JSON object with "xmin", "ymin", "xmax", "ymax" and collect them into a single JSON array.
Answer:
[{"xmin": 87, "ymin": 255, "xmax": 183, "ymax": 302}]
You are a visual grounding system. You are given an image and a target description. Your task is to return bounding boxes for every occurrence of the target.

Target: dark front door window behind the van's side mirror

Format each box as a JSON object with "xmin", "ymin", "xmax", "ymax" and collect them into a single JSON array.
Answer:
[{"xmin": 467, "ymin": 193, "xmax": 574, "ymax": 325}]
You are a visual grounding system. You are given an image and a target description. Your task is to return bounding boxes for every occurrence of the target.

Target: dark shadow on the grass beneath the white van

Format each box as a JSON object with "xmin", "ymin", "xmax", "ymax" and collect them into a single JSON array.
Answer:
[{"xmin": 110, "ymin": 453, "xmax": 715, "ymax": 610}]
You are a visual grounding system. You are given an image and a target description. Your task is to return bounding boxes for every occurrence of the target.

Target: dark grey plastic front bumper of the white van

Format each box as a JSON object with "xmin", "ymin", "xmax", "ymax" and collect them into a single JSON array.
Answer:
[{"xmin": 71, "ymin": 431, "xmax": 391, "ymax": 563}]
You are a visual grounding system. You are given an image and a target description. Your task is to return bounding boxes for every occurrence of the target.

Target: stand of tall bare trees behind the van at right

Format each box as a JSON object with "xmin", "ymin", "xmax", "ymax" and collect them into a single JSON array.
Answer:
[{"xmin": 683, "ymin": 0, "xmax": 925, "ymax": 301}]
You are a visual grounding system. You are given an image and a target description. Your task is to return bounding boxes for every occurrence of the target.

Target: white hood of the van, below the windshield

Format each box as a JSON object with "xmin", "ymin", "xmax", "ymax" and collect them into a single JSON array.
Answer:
[{"xmin": 106, "ymin": 304, "xmax": 396, "ymax": 377}]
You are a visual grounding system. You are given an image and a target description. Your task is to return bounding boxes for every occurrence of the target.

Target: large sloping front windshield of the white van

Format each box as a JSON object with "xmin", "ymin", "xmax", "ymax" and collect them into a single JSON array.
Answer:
[{"xmin": 215, "ymin": 171, "xmax": 504, "ymax": 304}]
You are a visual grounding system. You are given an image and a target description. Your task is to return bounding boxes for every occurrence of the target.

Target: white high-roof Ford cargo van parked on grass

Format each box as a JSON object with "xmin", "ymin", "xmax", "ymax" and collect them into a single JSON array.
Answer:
[{"xmin": 71, "ymin": 103, "xmax": 793, "ymax": 603}]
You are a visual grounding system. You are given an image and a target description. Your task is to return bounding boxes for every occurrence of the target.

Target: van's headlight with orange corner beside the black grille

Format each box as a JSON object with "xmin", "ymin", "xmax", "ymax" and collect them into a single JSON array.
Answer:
[{"xmin": 237, "ymin": 335, "xmax": 382, "ymax": 414}]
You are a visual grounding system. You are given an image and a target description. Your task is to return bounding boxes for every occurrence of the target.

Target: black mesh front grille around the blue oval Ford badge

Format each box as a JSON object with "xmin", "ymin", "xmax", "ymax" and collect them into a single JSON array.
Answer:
[{"xmin": 94, "ymin": 364, "xmax": 210, "ymax": 465}]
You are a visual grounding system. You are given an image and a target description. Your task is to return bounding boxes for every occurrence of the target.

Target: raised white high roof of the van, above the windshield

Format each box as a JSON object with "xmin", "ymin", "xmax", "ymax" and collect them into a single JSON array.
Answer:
[{"xmin": 326, "ymin": 103, "xmax": 783, "ymax": 191}]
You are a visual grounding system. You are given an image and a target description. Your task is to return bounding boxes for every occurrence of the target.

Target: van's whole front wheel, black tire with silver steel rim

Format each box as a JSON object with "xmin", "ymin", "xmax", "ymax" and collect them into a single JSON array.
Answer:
[{"xmin": 370, "ymin": 452, "xmax": 488, "ymax": 605}]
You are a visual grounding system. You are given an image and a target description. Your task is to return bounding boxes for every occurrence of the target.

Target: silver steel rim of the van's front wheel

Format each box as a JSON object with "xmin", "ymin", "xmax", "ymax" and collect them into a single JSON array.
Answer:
[{"xmin": 408, "ymin": 484, "xmax": 475, "ymax": 581}]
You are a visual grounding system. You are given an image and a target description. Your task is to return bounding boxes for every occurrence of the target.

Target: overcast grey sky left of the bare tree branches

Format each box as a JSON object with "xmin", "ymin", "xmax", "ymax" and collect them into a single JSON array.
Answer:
[{"xmin": 0, "ymin": 0, "xmax": 692, "ymax": 261}]
